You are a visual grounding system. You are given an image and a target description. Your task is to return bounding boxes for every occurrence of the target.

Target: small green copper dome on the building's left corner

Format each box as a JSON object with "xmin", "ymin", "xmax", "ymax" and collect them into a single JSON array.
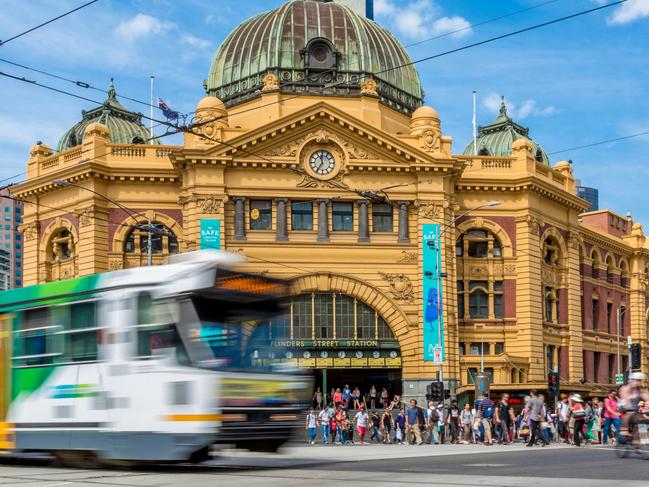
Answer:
[{"xmin": 56, "ymin": 79, "xmax": 160, "ymax": 152}]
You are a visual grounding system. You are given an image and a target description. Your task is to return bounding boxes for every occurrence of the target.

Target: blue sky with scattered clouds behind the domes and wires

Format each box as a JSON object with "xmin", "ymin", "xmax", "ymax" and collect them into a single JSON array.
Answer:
[{"xmin": 0, "ymin": 0, "xmax": 649, "ymax": 228}]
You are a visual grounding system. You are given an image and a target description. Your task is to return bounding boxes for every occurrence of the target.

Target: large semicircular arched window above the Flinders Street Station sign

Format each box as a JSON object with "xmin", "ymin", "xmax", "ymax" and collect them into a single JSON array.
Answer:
[{"xmin": 270, "ymin": 293, "xmax": 396, "ymax": 341}]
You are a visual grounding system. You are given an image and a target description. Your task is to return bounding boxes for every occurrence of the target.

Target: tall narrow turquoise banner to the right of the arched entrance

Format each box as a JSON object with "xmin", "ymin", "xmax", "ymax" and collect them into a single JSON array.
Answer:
[{"xmin": 421, "ymin": 223, "xmax": 446, "ymax": 365}]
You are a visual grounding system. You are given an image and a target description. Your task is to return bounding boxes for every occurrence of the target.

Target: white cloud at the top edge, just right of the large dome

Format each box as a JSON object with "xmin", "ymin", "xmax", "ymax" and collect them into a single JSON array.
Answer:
[{"xmin": 374, "ymin": 0, "xmax": 471, "ymax": 40}]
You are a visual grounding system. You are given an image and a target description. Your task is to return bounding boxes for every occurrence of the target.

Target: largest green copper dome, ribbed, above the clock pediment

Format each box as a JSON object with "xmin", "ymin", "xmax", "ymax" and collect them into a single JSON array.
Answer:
[{"xmin": 205, "ymin": 0, "xmax": 424, "ymax": 114}]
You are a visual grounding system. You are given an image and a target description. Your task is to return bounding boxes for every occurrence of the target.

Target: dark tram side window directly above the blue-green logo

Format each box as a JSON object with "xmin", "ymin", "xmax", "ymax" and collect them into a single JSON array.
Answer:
[{"xmin": 66, "ymin": 302, "xmax": 97, "ymax": 362}]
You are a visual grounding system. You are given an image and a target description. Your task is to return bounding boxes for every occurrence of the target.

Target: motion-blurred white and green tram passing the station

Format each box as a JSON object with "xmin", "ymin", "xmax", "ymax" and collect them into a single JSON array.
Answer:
[{"xmin": 0, "ymin": 251, "xmax": 311, "ymax": 463}]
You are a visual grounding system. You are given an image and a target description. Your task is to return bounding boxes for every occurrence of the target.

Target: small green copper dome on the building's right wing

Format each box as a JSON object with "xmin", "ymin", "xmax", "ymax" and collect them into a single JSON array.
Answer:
[{"xmin": 462, "ymin": 98, "xmax": 550, "ymax": 166}]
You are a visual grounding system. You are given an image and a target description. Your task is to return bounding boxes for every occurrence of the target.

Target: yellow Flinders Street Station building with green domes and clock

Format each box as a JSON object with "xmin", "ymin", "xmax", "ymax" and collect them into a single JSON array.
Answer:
[{"xmin": 13, "ymin": 0, "xmax": 649, "ymax": 404}]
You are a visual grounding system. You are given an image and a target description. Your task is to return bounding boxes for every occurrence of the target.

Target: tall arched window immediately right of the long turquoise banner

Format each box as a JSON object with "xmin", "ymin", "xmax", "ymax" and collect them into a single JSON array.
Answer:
[{"xmin": 455, "ymin": 228, "xmax": 504, "ymax": 320}]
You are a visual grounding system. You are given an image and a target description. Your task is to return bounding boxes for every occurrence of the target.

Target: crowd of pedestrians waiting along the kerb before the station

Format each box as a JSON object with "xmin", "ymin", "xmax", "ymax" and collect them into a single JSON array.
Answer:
[{"xmin": 305, "ymin": 386, "xmax": 623, "ymax": 447}]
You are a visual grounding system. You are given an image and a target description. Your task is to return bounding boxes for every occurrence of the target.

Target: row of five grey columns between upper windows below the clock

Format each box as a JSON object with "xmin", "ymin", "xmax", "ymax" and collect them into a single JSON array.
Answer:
[{"xmin": 232, "ymin": 196, "xmax": 410, "ymax": 243}]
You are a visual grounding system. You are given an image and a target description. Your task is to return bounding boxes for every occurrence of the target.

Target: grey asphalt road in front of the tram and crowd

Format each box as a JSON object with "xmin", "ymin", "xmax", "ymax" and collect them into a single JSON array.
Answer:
[{"xmin": 0, "ymin": 445, "xmax": 649, "ymax": 487}]
